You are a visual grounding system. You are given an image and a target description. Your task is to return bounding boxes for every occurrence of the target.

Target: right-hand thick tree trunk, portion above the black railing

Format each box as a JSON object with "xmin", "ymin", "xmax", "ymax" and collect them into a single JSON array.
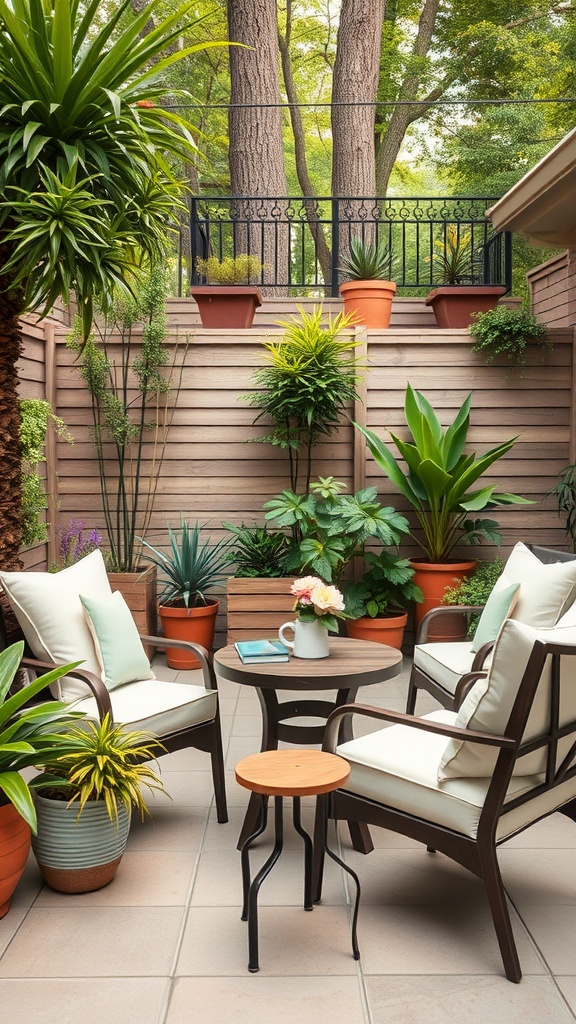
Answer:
[{"xmin": 332, "ymin": 0, "xmax": 384, "ymax": 198}]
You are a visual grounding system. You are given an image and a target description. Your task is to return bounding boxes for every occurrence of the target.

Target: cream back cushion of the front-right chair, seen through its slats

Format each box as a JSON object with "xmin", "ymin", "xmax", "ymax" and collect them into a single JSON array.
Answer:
[{"xmin": 439, "ymin": 618, "xmax": 576, "ymax": 779}]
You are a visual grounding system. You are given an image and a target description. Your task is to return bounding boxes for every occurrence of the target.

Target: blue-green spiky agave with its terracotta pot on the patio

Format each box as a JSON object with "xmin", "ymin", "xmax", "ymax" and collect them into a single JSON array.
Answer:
[{"xmin": 142, "ymin": 520, "xmax": 231, "ymax": 669}]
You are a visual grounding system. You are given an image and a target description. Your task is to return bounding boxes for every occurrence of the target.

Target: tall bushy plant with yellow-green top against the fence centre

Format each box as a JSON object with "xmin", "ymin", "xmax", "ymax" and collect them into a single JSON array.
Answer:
[{"xmin": 244, "ymin": 307, "xmax": 360, "ymax": 493}]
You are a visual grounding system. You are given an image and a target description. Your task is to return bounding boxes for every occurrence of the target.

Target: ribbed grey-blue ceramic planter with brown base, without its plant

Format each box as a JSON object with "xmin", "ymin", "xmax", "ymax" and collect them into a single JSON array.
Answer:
[{"xmin": 32, "ymin": 793, "xmax": 130, "ymax": 893}]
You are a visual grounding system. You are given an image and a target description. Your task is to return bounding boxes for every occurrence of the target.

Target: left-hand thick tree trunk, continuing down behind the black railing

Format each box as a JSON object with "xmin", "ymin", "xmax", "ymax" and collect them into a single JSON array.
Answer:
[{"xmin": 228, "ymin": 0, "xmax": 288, "ymax": 294}]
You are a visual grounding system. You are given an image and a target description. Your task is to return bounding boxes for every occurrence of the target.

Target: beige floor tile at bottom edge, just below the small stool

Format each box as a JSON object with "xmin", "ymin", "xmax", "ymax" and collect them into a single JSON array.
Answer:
[{"xmin": 166, "ymin": 973, "xmax": 364, "ymax": 1024}]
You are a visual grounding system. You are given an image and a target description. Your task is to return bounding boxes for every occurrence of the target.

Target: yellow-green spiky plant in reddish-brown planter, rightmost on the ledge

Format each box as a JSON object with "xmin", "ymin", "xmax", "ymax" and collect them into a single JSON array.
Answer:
[{"xmin": 425, "ymin": 224, "xmax": 506, "ymax": 329}]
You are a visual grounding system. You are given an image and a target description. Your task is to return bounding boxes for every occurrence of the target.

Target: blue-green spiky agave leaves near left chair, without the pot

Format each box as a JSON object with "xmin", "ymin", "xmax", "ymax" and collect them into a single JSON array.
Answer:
[{"xmin": 139, "ymin": 520, "xmax": 232, "ymax": 608}]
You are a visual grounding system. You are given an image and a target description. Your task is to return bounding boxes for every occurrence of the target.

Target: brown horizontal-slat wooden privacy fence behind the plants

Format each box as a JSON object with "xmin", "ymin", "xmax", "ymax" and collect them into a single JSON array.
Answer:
[{"xmin": 15, "ymin": 300, "xmax": 576, "ymax": 643}]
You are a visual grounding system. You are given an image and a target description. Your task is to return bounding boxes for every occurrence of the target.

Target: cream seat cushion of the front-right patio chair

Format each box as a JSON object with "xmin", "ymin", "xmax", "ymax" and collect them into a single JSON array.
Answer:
[{"xmin": 336, "ymin": 711, "xmax": 561, "ymax": 840}]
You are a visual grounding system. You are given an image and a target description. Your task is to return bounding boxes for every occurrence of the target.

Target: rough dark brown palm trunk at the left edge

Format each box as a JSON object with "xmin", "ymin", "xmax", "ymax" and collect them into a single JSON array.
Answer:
[{"xmin": 0, "ymin": 245, "xmax": 23, "ymax": 570}]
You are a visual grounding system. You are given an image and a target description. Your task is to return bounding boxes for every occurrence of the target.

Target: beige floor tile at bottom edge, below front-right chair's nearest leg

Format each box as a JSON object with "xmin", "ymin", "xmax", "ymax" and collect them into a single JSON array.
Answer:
[{"xmin": 366, "ymin": 976, "xmax": 573, "ymax": 1024}]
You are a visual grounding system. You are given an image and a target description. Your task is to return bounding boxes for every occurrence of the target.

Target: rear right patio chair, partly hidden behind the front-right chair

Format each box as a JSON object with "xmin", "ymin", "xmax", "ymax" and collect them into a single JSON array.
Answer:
[{"xmin": 406, "ymin": 543, "xmax": 576, "ymax": 715}]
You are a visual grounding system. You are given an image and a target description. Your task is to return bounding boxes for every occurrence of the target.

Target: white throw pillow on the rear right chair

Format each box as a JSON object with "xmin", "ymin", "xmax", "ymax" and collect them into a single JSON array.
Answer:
[{"xmin": 502, "ymin": 542, "xmax": 576, "ymax": 629}]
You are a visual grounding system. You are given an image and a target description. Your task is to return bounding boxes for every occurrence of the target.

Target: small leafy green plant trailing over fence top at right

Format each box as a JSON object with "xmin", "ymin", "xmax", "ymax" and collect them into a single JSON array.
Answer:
[{"xmin": 470, "ymin": 306, "xmax": 552, "ymax": 376}]
